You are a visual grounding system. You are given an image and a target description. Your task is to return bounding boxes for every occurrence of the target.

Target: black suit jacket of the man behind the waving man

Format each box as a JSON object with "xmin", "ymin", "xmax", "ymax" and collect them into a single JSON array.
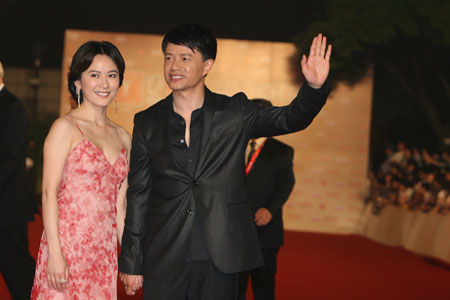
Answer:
[{"xmin": 245, "ymin": 138, "xmax": 295, "ymax": 248}]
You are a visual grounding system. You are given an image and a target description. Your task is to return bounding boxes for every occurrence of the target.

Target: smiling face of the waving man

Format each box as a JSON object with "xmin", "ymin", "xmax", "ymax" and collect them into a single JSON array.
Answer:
[{"xmin": 164, "ymin": 43, "xmax": 214, "ymax": 92}]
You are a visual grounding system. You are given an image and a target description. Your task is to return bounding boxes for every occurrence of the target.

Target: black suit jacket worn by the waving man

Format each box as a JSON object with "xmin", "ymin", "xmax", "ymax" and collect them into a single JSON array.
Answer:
[{"xmin": 119, "ymin": 84, "xmax": 330, "ymax": 279}]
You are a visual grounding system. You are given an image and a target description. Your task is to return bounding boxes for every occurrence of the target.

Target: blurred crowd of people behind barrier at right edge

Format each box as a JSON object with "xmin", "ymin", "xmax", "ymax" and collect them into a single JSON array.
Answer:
[{"xmin": 366, "ymin": 141, "xmax": 450, "ymax": 214}]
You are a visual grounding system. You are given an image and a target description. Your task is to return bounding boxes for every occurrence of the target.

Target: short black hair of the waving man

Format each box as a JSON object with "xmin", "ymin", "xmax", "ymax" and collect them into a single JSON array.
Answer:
[{"xmin": 161, "ymin": 23, "xmax": 217, "ymax": 61}]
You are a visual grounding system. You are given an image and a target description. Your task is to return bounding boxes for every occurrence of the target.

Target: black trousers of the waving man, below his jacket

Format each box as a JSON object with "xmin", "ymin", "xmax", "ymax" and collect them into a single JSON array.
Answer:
[{"xmin": 143, "ymin": 260, "xmax": 238, "ymax": 300}]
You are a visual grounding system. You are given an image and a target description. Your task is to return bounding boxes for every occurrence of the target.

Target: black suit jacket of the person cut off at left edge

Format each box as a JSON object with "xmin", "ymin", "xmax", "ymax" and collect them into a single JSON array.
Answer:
[{"xmin": 0, "ymin": 87, "xmax": 35, "ymax": 227}]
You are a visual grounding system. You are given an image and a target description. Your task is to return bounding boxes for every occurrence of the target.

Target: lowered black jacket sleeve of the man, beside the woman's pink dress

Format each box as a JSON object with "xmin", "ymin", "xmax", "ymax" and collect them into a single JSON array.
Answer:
[{"xmin": 119, "ymin": 117, "xmax": 152, "ymax": 275}]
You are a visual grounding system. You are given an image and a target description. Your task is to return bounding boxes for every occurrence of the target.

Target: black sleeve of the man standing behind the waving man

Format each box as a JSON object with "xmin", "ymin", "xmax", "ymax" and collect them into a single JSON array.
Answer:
[{"xmin": 264, "ymin": 147, "xmax": 295, "ymax": 215}]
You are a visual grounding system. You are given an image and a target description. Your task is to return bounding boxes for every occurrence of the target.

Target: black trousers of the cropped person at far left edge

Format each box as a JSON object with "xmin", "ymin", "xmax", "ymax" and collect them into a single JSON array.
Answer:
[{"xmin": 0, "ymin": 223, "xmax": 36, "ymax": 300}]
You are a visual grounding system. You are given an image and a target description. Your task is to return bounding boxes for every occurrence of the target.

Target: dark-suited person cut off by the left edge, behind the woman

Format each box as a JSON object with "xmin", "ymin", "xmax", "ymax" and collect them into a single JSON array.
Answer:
[{"xmin": 0, "ymin": 62, "xmax": 35, "ymax": 300}]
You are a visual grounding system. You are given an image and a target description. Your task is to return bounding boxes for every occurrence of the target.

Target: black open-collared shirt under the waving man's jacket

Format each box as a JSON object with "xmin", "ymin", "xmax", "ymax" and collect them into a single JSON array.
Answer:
[{"xmin": 170, "ymin": 106, "xmax": 209, "ymax": 261}]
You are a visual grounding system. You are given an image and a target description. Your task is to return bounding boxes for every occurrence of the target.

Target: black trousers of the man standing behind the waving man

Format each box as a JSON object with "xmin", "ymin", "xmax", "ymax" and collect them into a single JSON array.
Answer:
[{"xmin": 238, "ymin": 248, "xmax": 280, "ymax": 300}]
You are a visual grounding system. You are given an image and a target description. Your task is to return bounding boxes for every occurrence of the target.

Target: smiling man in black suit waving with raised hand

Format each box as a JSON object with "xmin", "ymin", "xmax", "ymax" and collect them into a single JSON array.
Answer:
[{"xmin": 119, "ymin": 24, "xmax": 331, "ymax": 300}]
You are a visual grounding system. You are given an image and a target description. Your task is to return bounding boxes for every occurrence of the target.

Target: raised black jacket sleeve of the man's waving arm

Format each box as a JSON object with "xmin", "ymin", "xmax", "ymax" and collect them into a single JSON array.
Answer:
[{"xmin": 240, "ymin": 82, "xmax": 331, "ymax": 138}]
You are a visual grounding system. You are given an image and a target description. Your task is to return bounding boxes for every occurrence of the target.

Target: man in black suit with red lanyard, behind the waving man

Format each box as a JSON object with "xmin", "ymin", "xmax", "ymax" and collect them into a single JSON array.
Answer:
[{"xmin": 239, "ymin": 99, "xmax": 295, "ymax": 300}]
